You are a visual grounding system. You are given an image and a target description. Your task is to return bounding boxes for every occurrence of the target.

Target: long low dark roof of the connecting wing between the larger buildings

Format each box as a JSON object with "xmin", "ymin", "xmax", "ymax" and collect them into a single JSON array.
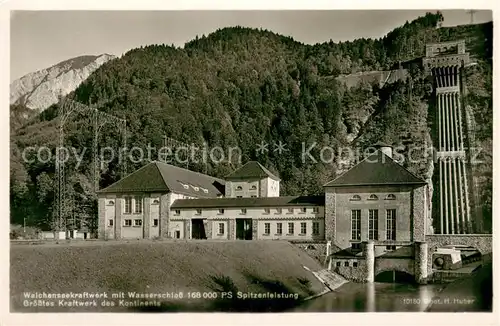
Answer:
[{"xmin": 170, "ymin": 196, "xmax": 325, "ymax": 209}]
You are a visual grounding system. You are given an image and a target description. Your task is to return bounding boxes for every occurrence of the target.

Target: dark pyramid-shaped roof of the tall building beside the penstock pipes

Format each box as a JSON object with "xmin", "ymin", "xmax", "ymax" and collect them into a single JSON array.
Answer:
[{"xmin": 324, "ymin": 151, "xmax": 426, "ymax": 187}]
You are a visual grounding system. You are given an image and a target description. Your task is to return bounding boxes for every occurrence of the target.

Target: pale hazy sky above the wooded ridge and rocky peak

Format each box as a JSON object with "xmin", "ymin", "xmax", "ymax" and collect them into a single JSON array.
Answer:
[{"xmin": 10, "ymin": 9, "xmax": 493, "ymax": 82}]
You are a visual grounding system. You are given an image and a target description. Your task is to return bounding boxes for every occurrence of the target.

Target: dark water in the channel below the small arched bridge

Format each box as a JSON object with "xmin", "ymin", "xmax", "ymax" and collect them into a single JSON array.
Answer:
[{"xmin": 292, "ymin": 283, "xmax": 445, "ymax": 312}]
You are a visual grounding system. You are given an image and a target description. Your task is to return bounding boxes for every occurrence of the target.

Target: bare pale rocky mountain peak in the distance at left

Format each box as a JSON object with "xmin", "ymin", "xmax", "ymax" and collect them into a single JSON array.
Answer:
[{"xmin": 10, "ymin": 54, "xmax": 116, "ymax": 110}]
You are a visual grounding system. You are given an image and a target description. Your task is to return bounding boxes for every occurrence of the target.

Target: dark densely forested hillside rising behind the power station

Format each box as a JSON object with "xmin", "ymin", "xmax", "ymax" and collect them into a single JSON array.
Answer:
[{"xmin": 11, "ymin": 13, "xmax": 492, "ymax": 232}]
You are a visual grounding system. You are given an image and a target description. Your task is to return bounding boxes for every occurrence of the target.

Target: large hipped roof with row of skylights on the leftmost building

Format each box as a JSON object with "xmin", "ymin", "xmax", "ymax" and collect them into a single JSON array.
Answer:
[{"xmin": 98, "ymin": 161, "xmax": 224, "ymax": 197}]
